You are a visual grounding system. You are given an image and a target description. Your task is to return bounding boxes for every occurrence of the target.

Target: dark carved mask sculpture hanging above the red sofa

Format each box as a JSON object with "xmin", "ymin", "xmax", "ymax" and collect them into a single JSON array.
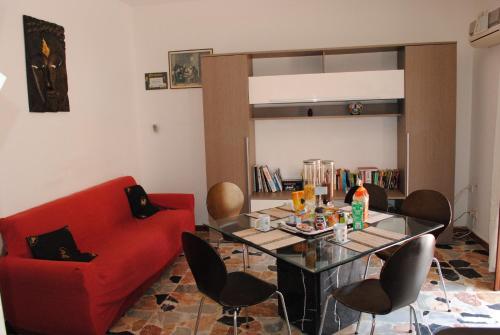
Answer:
[{"xmin": 23, "ymin": 15, "xmax": 69, "ymax": 113}]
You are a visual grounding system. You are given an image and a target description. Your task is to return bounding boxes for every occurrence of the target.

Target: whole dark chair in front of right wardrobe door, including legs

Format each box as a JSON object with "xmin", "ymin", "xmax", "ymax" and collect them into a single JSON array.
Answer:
[{"xmin": 365, "ymin": 190, "xmax": 452, "ymax": 312}]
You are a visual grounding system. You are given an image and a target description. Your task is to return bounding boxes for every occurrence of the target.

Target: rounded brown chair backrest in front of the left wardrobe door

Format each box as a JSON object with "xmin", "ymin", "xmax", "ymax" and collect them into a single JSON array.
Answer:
[{"xmin": 207, "ymin": 182, "xmax": 245, "ymax": 220}]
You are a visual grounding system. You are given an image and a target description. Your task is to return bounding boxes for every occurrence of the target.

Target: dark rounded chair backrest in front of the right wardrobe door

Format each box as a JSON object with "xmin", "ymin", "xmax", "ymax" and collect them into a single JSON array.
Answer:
[{"xmin": 401, "ymin": 190, "xmax": 452, "ymax": 239}]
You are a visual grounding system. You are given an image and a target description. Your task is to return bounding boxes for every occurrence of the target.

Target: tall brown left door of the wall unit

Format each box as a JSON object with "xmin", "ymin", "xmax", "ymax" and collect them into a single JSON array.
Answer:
[{"xmin": 202, "ymin": 55, "xmax": 255, "ymax": 211}]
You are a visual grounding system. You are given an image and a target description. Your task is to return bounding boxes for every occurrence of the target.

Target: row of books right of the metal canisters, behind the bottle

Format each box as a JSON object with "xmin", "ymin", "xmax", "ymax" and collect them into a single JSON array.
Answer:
[{"xmin": 336, "ymin": 167, "xmax": 399, "ymax": 193}]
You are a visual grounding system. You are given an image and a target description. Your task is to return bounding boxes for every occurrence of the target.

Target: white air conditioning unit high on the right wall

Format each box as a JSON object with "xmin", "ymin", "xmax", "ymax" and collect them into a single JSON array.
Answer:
[{"xmin": 469, "ymin": 7, "xmax": 500, "ymax": 48}]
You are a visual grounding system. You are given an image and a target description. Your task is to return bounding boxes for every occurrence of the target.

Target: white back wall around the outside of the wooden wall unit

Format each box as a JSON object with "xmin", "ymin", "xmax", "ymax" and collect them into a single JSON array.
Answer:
[{"xmin": 131, "ymin": 0, "xmax": 480, "ymax": 227}]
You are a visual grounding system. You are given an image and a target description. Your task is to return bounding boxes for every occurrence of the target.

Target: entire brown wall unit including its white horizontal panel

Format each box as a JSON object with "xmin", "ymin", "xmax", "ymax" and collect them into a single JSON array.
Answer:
[{"xmin": 202, "ymin": 42, "xmax": 456, "ymax": 242}]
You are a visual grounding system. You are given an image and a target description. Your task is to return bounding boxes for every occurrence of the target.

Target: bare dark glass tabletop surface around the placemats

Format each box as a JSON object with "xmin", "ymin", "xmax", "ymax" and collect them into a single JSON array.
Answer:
[{"xmin": 206, "ymin": 205, "xmax": 443, "ymax": 273}]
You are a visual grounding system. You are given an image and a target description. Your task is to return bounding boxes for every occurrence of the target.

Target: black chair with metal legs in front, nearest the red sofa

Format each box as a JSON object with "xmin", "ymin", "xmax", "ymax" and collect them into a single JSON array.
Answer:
[{"xmin": 182, "ymin": 232, "xmax": 292, "ymax": 335}]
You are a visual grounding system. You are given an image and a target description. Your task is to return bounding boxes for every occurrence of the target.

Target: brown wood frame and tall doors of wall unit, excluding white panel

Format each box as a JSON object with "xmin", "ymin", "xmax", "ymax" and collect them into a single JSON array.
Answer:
[{"xmin": 202, "ymin": 42, "xmax": 457, "ymax": 243}]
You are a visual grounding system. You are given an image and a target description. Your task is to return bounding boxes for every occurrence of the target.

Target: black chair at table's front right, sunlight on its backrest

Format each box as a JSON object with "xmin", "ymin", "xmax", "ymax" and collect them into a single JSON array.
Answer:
[{"xmin": 319, "ymin": 234, "xmax": 435, "ymax": 335}]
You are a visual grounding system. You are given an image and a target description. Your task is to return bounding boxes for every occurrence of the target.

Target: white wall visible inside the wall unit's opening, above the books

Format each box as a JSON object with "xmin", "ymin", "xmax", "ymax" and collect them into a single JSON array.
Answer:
[{"xmin": 255, "ymin": 117, "xmax": 397, "ymax": 178}]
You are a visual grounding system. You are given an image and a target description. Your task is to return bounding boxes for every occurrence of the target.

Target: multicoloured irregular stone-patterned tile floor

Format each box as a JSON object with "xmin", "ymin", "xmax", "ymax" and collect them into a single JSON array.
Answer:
[{"xmin": 109, "ymin": 234, "xmax": 500, "ymax": 335}]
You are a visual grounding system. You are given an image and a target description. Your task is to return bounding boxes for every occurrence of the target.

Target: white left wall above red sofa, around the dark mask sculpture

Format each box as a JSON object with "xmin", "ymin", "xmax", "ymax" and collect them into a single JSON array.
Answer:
[{"xmin": 0, "ymin": 0, "xmax": 138, "ymax": 217}]
